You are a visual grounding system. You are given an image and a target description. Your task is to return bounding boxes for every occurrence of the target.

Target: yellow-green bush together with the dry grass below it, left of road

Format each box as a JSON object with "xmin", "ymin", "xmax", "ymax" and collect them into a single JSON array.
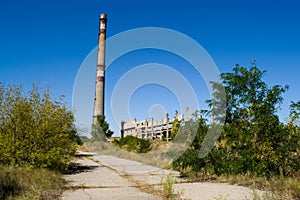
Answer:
[{"xmin": 0, "ymin": 83, "xmax": 81, "ymax": 199}]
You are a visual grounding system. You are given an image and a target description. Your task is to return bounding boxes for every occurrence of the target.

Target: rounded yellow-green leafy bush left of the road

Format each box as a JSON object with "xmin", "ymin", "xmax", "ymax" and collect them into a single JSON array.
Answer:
[{"xmin": 0, "ymin": 83, "xmax": 80, "ymax": 169}]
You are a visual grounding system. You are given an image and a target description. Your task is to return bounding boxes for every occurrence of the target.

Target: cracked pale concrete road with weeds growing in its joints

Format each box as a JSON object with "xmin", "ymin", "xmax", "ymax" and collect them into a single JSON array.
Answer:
[{"xmin": 62, "ymin": 153, "xmax": 261, "ymax": 200}]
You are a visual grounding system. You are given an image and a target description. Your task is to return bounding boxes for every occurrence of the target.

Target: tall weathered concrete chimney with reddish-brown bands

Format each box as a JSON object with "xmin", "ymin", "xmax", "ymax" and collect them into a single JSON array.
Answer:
[{"xmin": 93, "ymin": 14, "xmax": 107, "ymax": 124}]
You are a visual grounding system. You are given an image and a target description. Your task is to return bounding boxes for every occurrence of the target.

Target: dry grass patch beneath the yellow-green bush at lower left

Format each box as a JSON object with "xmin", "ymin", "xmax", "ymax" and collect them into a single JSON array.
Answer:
[{"xmin": 0, "ymin": 166, "xmax": 66, "ymax": 200}]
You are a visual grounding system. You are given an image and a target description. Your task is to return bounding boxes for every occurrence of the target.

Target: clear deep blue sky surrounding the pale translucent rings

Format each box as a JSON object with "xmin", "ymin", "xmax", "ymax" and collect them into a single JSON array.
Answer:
[{"xmin": 0, "ymin": 0, "xmax": 300, "ymax": 136}]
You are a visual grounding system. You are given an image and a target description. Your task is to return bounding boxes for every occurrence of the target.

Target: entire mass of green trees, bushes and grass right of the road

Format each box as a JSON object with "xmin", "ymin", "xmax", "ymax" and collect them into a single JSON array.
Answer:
[{"xmin": 172, "ymin": 62, "xmax": 300, "ymax": 199}]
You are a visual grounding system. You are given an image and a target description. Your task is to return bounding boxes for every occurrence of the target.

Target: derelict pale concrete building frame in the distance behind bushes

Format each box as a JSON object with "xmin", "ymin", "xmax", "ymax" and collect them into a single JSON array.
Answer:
[{"xmin": 121, "ymin": 111, "xmax": 183, "ymax": 140}]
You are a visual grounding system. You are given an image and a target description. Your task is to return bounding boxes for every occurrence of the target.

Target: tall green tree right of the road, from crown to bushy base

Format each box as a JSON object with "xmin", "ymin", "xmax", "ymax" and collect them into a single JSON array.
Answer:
[{"xmin": 206, "ymin": 61, "xmax": 291, "ymax": 175}]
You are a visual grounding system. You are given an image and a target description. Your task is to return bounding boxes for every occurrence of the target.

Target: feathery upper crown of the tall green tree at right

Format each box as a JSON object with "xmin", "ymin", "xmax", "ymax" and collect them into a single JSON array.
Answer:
[{"xmin": 217, "ymin": 61, "xmax": 288, "ymax": 123}]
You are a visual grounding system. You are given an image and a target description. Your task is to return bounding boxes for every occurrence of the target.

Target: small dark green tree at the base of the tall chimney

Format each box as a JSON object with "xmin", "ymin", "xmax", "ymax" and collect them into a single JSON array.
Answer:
[{"xmin": 92, "ymin": 115, "xmax": 114, "ymax": 141}]
